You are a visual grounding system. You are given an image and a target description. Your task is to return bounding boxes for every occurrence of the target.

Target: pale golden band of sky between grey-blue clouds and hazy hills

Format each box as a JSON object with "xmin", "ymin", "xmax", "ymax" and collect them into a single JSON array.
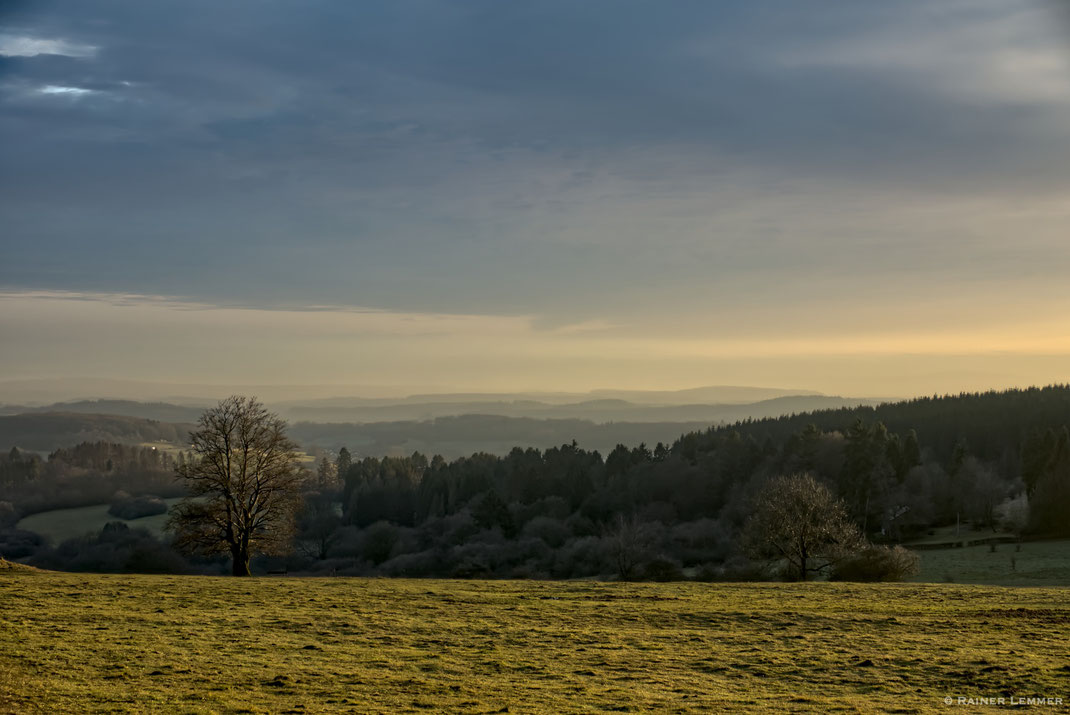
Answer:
[{"xmin": 0, "ymin": 291, "xmax": 1070, "ymax": 400}]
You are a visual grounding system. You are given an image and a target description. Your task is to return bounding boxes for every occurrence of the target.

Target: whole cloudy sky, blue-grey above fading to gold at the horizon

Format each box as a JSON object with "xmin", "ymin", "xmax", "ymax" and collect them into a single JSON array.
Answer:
[{"xmin": 0, "ymin": 0, "xmax": 1070, "ymax": 401}]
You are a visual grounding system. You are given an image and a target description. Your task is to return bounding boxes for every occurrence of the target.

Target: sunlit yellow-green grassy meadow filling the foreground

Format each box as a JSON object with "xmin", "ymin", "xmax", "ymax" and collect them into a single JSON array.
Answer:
[{"xmin": 0, "ymin": 569, "xmax": 1070, "ymax": 713}]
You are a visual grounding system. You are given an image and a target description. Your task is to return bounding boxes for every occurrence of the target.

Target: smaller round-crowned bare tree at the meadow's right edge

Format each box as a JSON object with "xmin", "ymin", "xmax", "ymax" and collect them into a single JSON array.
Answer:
[{"xmin": 744, "ymin": 474, "xmax": 865, "ymax": 581}]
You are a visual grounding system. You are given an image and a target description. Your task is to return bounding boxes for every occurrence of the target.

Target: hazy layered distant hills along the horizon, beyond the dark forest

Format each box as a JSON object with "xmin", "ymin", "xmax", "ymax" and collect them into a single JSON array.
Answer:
[{"xmin": 0, "ymin": 387, "xmax": 877, "ymax": 457}]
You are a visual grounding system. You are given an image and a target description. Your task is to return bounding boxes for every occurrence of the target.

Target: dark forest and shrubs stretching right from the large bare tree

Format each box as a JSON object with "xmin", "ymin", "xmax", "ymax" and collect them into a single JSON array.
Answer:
[{"xmin": 169, "ymin": 387, "xmax": 1070, "ymax": 578}]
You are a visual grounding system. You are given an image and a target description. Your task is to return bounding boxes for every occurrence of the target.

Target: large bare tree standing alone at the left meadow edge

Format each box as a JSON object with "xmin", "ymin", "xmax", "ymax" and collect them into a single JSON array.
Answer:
[{"xmin": 168, "ymin": 396, "xmax": 303, "ymax": 576}]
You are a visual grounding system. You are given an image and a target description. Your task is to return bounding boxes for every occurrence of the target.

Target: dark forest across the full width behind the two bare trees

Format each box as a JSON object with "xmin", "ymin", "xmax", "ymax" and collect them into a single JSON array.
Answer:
[{"xmin": 0, "ymin": 385, "xmax": 1070, "ymax": 580}]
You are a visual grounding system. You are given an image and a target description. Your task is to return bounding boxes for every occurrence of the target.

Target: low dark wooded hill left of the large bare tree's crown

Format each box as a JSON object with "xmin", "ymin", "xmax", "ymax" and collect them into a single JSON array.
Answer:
[{"xmin": 0, "ymin": 412, "xmax": 194, "ymax": 452}]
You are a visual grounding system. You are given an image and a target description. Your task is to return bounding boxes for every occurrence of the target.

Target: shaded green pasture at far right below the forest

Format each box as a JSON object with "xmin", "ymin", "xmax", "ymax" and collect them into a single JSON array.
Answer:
[{"xmin": 914, "ymin": 539, "xmax": 1070, "ymax": 585}]
